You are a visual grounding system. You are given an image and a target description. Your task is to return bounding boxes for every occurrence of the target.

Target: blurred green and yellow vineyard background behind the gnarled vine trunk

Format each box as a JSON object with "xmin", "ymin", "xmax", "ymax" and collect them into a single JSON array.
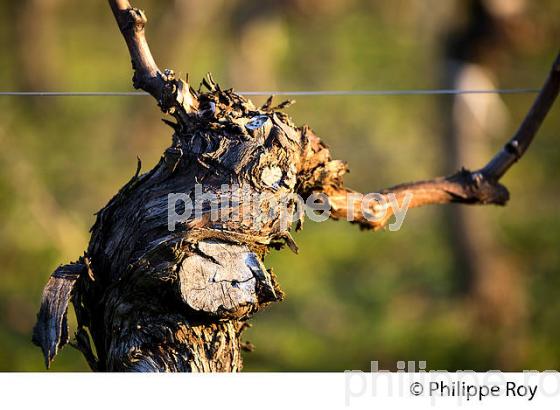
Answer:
[{"xmin": 0, "ymin": 0, "xmax": 560, "ymax": 371}]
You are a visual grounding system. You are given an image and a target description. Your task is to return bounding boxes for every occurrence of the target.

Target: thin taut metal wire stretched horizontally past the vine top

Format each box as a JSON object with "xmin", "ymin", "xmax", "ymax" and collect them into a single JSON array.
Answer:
[{"xmin": 0, "ymin": 88, "xmax": 540, "ymax": 97}]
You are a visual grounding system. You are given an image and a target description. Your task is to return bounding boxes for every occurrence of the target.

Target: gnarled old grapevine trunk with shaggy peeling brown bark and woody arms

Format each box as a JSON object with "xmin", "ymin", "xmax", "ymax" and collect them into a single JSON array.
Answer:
[{"xmin": 34, "ymin": 0, "xmax": 559, "ymax": 371}]
